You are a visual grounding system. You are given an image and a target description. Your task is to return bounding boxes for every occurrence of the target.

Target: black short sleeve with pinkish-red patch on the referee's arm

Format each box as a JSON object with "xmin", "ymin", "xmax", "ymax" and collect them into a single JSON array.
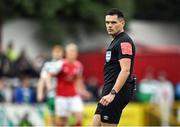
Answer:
[{"xmin": 117, "ymin": 41, "xmax": 133, "ymax": 59}]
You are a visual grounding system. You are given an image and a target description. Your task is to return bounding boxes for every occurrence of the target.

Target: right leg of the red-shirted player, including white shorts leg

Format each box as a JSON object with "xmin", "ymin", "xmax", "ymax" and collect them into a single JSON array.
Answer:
[{"xmin": 70, "ymin": 96, "xmax": 84, "ymax": 126}]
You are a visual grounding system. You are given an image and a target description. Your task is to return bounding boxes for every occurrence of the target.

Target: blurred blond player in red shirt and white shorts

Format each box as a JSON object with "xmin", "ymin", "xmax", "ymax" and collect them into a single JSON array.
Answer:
[{"xmin": 47, "ymin": 43, "xmax": 91, "ymax": 126}]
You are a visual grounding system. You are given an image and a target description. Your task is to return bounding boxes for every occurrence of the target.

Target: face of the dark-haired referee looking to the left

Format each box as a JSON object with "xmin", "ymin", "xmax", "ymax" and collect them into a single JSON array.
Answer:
[{"xmin": 105, "ymin": 15, "xmax": 125, "ymax": 36}]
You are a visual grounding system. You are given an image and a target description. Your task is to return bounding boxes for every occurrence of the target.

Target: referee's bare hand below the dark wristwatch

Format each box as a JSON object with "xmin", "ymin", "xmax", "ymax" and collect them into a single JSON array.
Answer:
[{"xmin": 99, "ymin": 93, "xmax": 115, "ymax": 106}]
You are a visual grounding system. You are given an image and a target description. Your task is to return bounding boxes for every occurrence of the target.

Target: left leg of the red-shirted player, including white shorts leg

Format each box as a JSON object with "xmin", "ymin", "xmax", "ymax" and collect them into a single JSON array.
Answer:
[{"xmin": 55, "ymin": 96, "xmax": 68, "ymax": 126}]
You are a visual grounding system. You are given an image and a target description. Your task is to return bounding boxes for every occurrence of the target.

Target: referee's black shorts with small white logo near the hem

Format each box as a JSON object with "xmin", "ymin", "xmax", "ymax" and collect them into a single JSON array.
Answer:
[{"xmin": 95, "ymin": 84, "xmax": 134, "ymax": 124}]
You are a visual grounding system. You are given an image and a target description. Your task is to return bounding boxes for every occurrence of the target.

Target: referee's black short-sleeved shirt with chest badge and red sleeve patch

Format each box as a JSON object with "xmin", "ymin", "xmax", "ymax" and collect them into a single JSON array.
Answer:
[{"xmin": 103, "ymin": 32, "xmax": 135, "ymax": 94}]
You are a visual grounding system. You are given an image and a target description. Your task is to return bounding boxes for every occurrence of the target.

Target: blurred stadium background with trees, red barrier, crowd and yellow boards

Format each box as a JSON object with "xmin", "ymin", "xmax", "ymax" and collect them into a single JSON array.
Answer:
[{"xmin": 0, "ymin": 0, "xmax": 180, "ymax": 126}]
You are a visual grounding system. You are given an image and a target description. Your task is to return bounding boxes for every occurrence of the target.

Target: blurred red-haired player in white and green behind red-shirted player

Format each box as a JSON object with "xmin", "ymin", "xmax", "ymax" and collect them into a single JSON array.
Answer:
[{"xmin": 37, "ymin": 45, "xmax": 64, "ymax": 124}]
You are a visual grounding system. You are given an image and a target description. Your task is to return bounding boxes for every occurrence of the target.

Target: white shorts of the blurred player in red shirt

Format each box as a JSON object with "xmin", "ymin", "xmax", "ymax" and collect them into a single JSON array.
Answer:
[{"xmin": 55, "ymin": 95, "xmax": 83, "ymax": 117}]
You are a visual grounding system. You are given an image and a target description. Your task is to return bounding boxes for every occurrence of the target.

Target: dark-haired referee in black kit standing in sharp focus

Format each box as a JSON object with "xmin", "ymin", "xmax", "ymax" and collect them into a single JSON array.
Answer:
[{"xmin": 93, "ymin": 8, "xmax": 135, "ymax": 126}]
